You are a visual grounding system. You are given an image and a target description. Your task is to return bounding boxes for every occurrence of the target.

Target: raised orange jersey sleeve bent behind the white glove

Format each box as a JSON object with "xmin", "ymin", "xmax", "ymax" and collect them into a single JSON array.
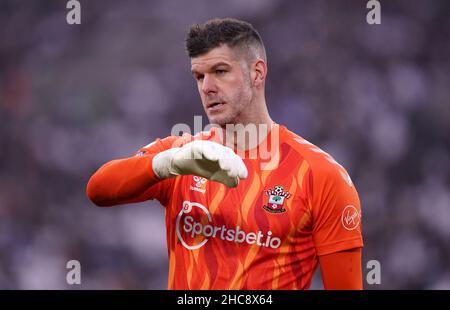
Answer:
[{"xmin": 86, "ymin": 136, "xmax": 182, "ymax": 206}]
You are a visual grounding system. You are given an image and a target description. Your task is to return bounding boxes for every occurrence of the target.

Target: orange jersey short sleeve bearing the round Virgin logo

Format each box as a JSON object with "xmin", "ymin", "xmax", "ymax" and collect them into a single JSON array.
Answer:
[{"xmin": 311, "ymin": 162, "xmax": 363, "ymax": 256}]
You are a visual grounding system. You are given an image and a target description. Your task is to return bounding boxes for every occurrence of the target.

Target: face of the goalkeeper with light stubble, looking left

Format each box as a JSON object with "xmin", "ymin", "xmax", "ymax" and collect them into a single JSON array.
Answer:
[{"xmin": 191, "ymin": 45, "xmax": 253, "ymax": 127}]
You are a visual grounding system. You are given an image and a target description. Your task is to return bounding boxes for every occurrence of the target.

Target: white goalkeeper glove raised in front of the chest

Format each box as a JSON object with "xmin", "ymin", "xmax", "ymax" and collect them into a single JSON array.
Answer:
[{"xmin": 152, "ymin": 140, "xmax": 248, "ymax": 187}]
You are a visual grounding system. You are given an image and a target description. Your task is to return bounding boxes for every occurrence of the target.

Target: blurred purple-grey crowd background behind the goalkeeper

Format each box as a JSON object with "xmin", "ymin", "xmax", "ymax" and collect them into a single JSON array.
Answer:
[{"xmin": 0, "ymin": 0, "xmax": 450, "ymax": 289}]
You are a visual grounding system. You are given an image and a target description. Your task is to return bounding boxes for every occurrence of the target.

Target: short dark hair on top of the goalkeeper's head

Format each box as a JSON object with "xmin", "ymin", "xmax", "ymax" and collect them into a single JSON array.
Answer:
[{"xmin": 186, "ymin": 18, "xmax": 266, "ymax": 60}]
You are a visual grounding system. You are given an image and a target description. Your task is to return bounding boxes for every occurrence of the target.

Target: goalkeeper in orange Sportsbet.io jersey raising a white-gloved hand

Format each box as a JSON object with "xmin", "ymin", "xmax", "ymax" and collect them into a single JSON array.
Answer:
[{"xmin": 87, "ymin": 19, "xmax": 363, "ymax": 289}]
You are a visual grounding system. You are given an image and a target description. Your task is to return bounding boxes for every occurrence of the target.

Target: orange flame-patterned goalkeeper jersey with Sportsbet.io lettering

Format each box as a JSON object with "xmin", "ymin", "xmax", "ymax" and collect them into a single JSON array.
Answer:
[{"xmin": 88, "ymin": 125, "xmax": 363, "ymax": 290}]
